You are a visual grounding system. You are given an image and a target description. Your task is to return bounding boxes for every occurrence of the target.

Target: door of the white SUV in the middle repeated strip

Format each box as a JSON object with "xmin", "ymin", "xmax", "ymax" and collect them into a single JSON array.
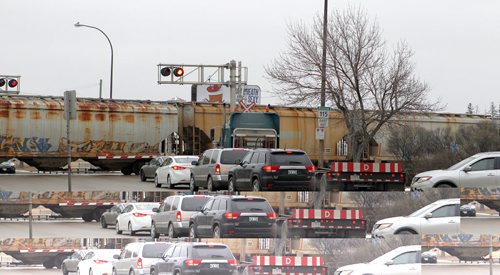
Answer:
[{"xmin": 420, "ymin": 204, "xmax": 460, "ymax": 234}]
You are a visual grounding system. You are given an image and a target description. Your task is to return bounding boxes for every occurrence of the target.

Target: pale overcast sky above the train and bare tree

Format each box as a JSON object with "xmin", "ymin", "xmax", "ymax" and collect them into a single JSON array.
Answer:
[{"xmin": 0, "ymin": 0, "xmax": 500, "ymax": 113}]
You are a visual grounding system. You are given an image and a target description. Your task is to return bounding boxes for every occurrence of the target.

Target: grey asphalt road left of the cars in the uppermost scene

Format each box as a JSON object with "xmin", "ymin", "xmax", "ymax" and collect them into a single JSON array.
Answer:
[{"xmin": 0, "ymin": 172, "xmax": 189, "ymax": 192}]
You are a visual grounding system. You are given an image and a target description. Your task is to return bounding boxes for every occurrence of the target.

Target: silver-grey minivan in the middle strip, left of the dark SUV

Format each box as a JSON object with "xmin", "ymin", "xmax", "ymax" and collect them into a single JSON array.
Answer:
[{"xmin": 151, "ymin": 195, "xmax": 212, "ymax": 238}]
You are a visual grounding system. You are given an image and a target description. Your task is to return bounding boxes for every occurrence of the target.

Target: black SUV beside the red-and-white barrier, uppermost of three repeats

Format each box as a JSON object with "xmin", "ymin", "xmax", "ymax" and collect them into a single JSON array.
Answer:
[{"xmin": 228, "ymin": 149, "xmax": 316, "ymax": 192}]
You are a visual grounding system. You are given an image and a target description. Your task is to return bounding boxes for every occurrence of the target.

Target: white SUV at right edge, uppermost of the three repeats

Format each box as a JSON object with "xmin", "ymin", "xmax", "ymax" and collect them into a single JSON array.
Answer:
[{"xmin": 411, "ymin": 152, "xmax": 500, "ymax": 190}]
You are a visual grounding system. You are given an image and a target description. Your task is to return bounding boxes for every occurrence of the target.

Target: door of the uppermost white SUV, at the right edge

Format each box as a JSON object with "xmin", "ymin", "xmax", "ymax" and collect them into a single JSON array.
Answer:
[{"xmin": 459, "ymin": 157, "xmax": 499, "ymax": 187}]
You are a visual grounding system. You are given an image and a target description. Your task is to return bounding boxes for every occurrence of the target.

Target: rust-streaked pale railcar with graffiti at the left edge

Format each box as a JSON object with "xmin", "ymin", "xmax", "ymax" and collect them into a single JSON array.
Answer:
[{"xmin": 0, "ymin": 96, "xmax": 178, "ymax": 174}]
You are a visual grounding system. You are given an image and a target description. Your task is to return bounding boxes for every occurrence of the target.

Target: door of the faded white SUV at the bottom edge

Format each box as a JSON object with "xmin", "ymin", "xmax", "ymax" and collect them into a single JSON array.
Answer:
[{"xmin": 381, "ymin": 251, "xmax": 421, "ymax": 275}]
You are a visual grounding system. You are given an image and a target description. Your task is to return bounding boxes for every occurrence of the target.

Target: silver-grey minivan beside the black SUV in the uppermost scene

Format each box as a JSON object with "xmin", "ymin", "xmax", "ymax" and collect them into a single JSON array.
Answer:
[{"xmin": 189, "ymin": 148, "xmax": 249, "ymax": 192}]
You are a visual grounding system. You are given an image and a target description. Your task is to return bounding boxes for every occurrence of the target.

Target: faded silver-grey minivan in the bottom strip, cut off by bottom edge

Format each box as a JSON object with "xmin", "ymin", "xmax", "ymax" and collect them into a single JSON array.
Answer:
[{"xmin": 112, "ymin": 242, "xmax": 172, "ymax": 275}]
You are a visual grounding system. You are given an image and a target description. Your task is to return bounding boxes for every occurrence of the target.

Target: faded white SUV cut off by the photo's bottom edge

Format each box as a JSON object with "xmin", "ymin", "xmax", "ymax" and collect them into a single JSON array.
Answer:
[{"xmin": 335, "ymin": 245, "xmax": 421, "ymax": 275}]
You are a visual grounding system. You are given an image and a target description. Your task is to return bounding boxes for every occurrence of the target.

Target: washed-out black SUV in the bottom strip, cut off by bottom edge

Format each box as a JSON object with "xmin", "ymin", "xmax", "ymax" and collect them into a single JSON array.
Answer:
[{"xmin": 150, "ymin": 243, "xmax": 238, "ymax": 275}]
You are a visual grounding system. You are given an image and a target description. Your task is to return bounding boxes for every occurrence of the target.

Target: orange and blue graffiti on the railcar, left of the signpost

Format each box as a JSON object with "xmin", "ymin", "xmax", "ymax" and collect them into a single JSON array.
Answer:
[{"xmin": 0, "ymin": 135, "xmax": 52, "ymax": 153}]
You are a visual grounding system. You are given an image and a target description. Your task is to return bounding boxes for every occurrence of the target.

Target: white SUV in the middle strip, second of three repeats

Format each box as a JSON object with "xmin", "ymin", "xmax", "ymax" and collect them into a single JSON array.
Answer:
[{"xmin": 372, "ymin": 198, "xmax": 460, "ymax": 237}]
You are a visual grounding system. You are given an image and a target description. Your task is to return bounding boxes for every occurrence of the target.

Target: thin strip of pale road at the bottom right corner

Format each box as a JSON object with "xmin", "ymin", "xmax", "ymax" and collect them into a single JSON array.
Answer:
[{"xmin": 422, "ymin": 263, "xmax": 500, "ymax": 275}]
